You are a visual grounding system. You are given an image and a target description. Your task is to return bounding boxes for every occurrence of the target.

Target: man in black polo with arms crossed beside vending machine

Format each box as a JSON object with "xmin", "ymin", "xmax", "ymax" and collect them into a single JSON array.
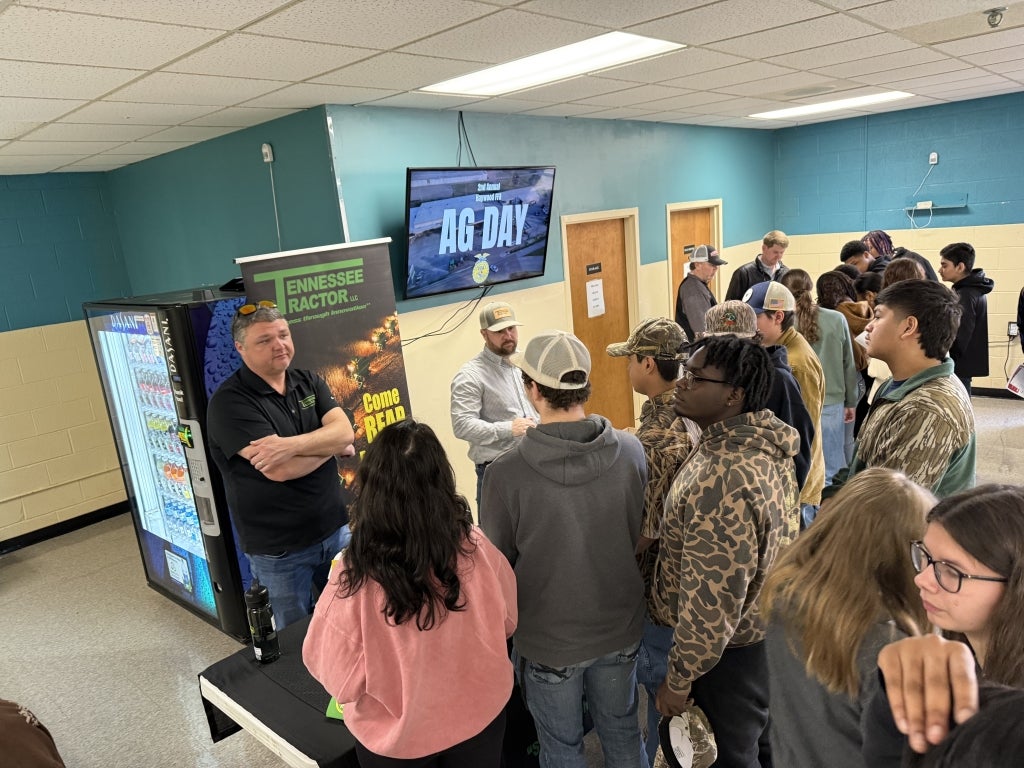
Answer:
[{"xmin": 207, "ymin": 301, "xmax": 354, "ymax": 630}]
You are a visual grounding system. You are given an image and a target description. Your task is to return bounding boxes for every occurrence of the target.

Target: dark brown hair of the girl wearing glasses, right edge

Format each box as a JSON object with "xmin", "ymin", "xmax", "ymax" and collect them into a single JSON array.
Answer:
[{"xmin": 928, "ymin": 483, "xmax": 1024, "ymax": 687}]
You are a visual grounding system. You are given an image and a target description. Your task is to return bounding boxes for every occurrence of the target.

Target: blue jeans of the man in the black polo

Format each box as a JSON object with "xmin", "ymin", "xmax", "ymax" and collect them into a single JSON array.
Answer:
[{"xmin": 246, "ymin": 525, "xmax": 352, "ymax": 630}]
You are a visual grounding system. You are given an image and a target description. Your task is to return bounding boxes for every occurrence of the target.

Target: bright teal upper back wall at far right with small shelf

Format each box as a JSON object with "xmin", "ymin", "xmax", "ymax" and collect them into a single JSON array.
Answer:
[{"xmin": 774, "ymin": 93, "xmax": 1024, "ymax": 234}]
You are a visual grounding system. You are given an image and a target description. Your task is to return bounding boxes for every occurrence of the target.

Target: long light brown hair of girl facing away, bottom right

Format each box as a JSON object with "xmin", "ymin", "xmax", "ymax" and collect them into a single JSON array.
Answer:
[{"xmin": 761, "ymin": 467, "xmax": 935, "ymax": 696}]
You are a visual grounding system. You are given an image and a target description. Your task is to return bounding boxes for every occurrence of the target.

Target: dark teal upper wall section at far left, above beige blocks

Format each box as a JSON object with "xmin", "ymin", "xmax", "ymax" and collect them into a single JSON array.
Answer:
[{"xmin": 0, "ymin": 173, "xmax": 129, "ymax": 332}]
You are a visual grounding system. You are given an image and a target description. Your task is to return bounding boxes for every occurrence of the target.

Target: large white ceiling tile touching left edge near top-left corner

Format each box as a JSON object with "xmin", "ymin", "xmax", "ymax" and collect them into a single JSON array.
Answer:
[{"xmin": 0, "ymin": 5, "xmax": 223, "ymax": 70}]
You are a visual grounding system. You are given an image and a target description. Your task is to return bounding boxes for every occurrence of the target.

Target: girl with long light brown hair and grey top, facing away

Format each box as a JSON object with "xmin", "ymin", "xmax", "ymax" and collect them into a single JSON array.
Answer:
[{"xmin": 762, "ymin": 467, "xmax": 935, "ymax": 768}]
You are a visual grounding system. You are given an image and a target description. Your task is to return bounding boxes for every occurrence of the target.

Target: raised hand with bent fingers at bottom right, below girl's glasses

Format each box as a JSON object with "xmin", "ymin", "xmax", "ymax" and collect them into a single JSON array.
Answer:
[{"xmin": 879, "ymin": 635, "xmax": 978, "ymax": 753}]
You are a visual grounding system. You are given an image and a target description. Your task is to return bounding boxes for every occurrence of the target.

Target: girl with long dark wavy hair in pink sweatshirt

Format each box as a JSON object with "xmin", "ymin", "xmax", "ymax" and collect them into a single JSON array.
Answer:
[{"xmin": 302, "ymin": 419, "xmax": 516, "ymax": 768}]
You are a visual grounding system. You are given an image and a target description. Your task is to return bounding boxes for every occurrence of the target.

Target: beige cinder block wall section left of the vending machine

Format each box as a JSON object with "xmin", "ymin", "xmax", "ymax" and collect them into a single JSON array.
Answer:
[{"xmin": 0, "ymin": 321, "xmax": 126, "ymax": 541}]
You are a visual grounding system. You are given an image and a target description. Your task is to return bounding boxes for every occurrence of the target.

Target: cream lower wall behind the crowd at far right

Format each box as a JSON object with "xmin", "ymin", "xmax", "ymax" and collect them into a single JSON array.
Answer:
[{"xmin": 717, "ymin": 224, "xmax": 1024, "ymax": 389}]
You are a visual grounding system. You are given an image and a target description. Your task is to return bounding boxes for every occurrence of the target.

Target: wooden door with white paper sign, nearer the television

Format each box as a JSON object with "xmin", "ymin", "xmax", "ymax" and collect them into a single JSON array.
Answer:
[{"xmin": 565, "ymin": 217, "xmax": 636, "ymax": 429}]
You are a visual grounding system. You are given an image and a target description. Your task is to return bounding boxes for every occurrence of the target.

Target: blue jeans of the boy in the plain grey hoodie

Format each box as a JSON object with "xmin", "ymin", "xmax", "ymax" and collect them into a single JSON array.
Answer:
[{"xmin": 512, "ymin": 642, "xmax": 646, "ymax": 768}]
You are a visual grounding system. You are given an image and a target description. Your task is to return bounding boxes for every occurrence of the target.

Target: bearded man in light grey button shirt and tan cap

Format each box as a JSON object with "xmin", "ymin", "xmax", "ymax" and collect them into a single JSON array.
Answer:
[{"xmin": 452, "ymin": 301, "xmax": 538, "ymax": 519}]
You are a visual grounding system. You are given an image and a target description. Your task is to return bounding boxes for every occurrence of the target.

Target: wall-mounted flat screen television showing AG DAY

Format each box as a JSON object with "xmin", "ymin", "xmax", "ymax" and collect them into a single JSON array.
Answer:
[{"xmin": 406, "ymin": 166, "xmax": 555, "ymax": 299}]
